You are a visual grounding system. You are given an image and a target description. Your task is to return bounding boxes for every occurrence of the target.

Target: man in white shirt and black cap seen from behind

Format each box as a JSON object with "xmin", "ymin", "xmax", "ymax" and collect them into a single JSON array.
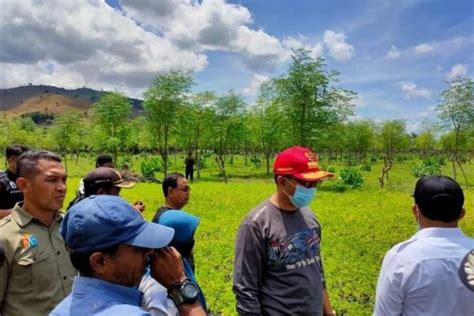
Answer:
[{"xmin": 374, "ymin": 176, "xmax": 474, "ymax": 316}]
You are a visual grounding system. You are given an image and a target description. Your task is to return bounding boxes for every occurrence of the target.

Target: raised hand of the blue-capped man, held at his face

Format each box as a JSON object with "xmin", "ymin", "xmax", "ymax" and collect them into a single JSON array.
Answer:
[{"xmin": 150, "ymin": 247, "xmax": 186, "ymax": 289}]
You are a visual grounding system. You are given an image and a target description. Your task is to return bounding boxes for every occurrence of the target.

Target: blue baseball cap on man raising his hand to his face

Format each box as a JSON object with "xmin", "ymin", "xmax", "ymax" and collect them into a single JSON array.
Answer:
[{"xmin": 61, "ymin": 195, "xmax": 174, "ymax": 253}]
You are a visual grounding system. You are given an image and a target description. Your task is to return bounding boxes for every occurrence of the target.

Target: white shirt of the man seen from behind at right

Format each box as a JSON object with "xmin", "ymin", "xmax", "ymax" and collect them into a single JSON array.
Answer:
[{"xmin": 374, "ymin": 228, "xmax": 474, "ymax": 316}]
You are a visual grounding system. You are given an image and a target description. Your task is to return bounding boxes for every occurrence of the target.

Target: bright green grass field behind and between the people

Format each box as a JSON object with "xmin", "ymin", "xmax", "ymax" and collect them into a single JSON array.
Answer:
[{"xmin": 37, "ymin": 157, "xmax": 474, "ymax": 315}]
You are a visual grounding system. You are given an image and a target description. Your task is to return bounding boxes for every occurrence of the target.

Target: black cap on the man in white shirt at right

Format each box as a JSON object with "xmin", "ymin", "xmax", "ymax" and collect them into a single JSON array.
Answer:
[{"xmin": 413, "ymin": 176, "xmax": 464, "ymax": 222}]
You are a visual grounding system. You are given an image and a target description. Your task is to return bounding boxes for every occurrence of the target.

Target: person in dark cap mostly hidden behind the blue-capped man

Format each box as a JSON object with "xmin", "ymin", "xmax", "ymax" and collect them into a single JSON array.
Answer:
[{"xmin": 68, "ymin": 167, "xmax": 145, "ymax": 213}]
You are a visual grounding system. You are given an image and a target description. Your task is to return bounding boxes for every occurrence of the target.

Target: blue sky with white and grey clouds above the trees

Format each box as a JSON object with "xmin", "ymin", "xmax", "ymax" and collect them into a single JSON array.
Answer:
[{"xmin": 0, "ymin": 0, "xmax": 474, "ymax": 131}]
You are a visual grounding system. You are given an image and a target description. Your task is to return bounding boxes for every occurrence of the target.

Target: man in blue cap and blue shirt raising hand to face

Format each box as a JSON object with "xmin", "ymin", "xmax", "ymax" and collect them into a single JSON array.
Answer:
[{"xmin": 51, "ymin": 195, "xmax": 205, "ymax": 315}]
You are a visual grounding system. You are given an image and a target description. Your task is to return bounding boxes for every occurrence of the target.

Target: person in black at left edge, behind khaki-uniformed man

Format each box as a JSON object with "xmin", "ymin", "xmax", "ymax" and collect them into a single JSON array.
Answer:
[{"xmin": 0, "ymin": 145, "xmax": 29, "ymax": 219}]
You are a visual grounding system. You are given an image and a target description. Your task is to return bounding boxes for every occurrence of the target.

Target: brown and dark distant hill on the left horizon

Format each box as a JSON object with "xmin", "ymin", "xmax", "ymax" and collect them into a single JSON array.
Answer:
[{"xmin": 0, "ymin": 85, "xmax": 142, "ymax": 117}]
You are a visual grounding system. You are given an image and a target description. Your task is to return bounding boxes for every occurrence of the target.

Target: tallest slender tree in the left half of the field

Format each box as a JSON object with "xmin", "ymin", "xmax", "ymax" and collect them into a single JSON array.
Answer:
[{"xmin": 143, "ymin": 70, "xmax": 194, "ymax": 176}]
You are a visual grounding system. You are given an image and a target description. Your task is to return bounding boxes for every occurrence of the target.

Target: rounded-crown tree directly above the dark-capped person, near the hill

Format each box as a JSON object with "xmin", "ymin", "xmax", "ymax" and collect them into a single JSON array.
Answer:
[{"xmin": 92, "ymin": 92, "xmax": 132, "ymax": 163}]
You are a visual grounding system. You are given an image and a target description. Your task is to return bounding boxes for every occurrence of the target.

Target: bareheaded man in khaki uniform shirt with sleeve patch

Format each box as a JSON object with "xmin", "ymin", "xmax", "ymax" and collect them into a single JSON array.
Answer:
[{"xmin": 0, "ymin": 151, "xmax": 76, "ymax": 316}]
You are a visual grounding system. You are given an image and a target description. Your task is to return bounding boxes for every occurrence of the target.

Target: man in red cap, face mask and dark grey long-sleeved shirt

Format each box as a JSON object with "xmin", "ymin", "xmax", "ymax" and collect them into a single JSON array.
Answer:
[{"xmin": 233, "ymin": 146, "xmax": 336, "ymax": 316}]
